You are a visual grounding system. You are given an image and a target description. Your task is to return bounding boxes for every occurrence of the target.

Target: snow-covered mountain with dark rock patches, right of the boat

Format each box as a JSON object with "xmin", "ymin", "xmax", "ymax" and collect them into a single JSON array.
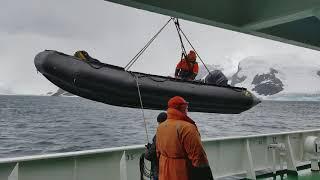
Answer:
[{"xmin": 231, "ymin": 55, "xmax": 320, "ymax": 96}]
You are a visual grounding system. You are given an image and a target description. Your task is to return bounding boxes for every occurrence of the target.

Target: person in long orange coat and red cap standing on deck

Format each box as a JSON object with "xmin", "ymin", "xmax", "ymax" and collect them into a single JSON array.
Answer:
[{"xmin": 156, "ymin": 96, "xmax": 213, "ymax": 180}]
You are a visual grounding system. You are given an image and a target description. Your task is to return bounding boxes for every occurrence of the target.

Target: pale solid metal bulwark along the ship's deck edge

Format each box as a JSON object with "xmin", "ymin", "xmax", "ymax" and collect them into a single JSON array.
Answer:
[{"xmin": 0, "ymin": 129, "xmax": 320, "ymax": 180}]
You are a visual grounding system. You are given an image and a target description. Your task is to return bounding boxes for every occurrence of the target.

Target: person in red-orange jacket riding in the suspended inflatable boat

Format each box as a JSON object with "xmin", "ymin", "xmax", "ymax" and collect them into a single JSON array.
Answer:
[{"xmin": 174, "ymin": 50, "xmax": 199, "ymax": 81}]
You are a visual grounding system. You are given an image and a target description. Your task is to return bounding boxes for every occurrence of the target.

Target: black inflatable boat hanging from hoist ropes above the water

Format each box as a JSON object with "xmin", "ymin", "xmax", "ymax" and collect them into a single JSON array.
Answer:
[{"xmin": 34, "ymin": 50, "xmax": 260, "ymax": 114}]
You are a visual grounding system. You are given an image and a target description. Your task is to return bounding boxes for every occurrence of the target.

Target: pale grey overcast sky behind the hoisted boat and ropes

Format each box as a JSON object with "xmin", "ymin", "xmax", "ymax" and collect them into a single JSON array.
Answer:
[{"xmin": 0, "ymin": 0, "xmax": 320, "ymax": 94}]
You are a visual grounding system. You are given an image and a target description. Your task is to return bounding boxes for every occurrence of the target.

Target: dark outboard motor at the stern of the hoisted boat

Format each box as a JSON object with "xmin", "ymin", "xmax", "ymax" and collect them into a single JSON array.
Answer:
[{"xmin": 202, "ymin": 70, "xmax": 228, "ymax": 86}]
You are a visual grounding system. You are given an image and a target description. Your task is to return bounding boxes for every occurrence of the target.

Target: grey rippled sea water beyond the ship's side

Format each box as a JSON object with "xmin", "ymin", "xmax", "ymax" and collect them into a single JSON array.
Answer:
[{"xmin": 0, "ymin": 96, "xmax": 320, "ymax": 158}]
